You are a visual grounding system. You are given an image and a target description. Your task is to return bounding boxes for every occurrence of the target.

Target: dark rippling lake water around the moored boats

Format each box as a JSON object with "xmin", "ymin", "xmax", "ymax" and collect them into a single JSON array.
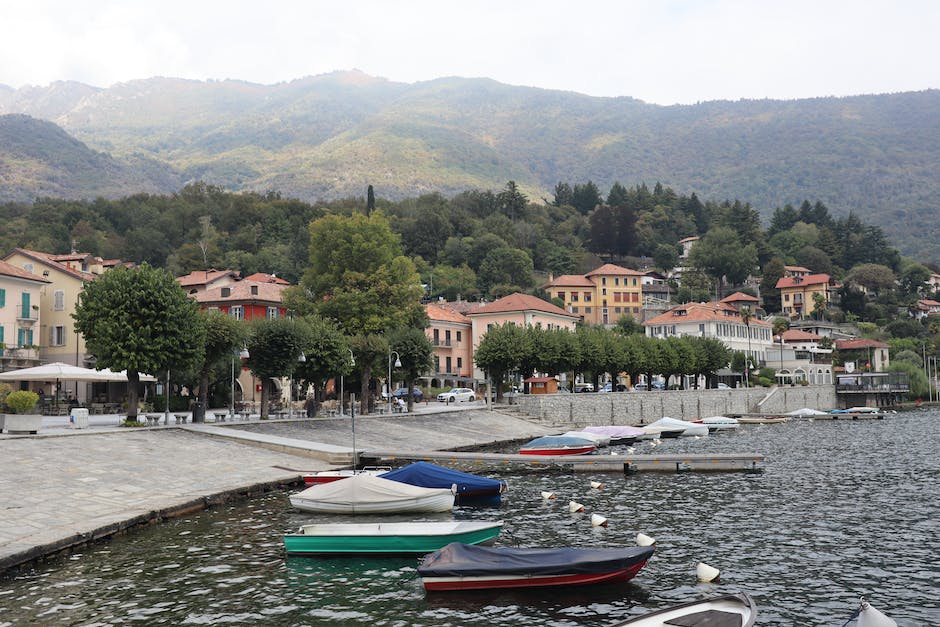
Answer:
[{"xmin": 0, "ymin": 411, "xmax": 940, "ymax": 627}]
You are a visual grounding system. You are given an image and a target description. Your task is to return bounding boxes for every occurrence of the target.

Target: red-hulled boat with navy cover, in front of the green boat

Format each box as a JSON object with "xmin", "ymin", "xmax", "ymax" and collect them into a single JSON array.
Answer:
[{"xmin": 418, "ymin": 542, "xmax": 655, "ymax": 591}]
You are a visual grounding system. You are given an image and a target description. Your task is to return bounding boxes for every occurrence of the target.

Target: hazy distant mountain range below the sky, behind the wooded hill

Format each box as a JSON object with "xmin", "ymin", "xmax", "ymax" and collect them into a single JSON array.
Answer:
[{"xmin": 0, "ymin": 72, "xmax": 940, "ymax": 261}]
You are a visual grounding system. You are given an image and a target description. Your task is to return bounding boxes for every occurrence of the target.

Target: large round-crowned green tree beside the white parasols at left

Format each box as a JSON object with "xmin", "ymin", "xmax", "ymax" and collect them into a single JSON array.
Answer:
[{"xmin": 72, "ymin": 263, "xmax": 206, "ymax": 420}]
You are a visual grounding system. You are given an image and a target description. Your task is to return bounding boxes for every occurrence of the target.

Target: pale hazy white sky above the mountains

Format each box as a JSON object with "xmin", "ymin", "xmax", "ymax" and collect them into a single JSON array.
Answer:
[{"xmin": 0, "ymin": 0, "xmax": 940, "ymax": 104}]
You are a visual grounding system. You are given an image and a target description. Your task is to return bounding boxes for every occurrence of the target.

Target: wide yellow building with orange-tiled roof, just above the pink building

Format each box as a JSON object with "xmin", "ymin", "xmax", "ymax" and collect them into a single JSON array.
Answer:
[{"xmin": 542, "ymin": 263, "xmax": 643, "ymax": 326}]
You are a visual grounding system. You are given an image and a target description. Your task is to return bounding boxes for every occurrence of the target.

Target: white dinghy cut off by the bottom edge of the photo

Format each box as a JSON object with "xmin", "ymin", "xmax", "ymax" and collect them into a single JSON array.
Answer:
[{"xmin": 611, "ymin": 592, "xmax": 757, "ymax": 627}]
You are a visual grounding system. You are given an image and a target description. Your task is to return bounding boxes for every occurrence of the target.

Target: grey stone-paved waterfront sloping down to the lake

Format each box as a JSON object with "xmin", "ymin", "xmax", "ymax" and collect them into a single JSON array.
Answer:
[{"xmin": 0, "ymin": 404, "xmax": 546, "ymax": 572}]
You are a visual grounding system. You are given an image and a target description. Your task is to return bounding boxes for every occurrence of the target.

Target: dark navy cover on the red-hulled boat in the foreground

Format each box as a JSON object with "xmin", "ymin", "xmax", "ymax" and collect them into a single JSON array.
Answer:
[{"xmin": 418, "ymin": 542, "xmax": 655, "ymax": 577}]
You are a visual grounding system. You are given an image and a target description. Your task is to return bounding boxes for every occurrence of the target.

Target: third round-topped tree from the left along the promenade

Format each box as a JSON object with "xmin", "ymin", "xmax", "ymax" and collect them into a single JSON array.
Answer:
[{"xmin": 246, "ymin": 318, "xmax": 308, "ymax": 420}]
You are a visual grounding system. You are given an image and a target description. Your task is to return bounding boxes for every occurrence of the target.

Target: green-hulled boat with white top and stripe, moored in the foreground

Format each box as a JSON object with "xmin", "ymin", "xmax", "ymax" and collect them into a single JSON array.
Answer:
[{"xmin": 284, "ymin": 520, "xmax": 503, "ymax": 555}]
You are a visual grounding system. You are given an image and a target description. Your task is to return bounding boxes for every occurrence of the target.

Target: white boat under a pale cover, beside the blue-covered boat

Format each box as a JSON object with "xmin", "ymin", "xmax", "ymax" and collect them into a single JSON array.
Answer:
[{"xmin": 290, "ymin": 475, "xmax": 455, "ymax": 514}]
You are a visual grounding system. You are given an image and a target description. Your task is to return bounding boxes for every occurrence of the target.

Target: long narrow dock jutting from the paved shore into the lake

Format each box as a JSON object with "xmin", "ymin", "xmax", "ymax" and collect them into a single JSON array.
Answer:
[{"xmin": 360, "ymin": 450, "xmax": 764, "ymax": 474}]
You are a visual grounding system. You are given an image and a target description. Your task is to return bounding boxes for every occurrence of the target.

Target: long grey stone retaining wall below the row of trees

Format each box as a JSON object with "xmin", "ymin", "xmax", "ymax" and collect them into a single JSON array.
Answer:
[{"xmin": 513, "ymin": 385, "xmax": 836, "ymax": 427}]
